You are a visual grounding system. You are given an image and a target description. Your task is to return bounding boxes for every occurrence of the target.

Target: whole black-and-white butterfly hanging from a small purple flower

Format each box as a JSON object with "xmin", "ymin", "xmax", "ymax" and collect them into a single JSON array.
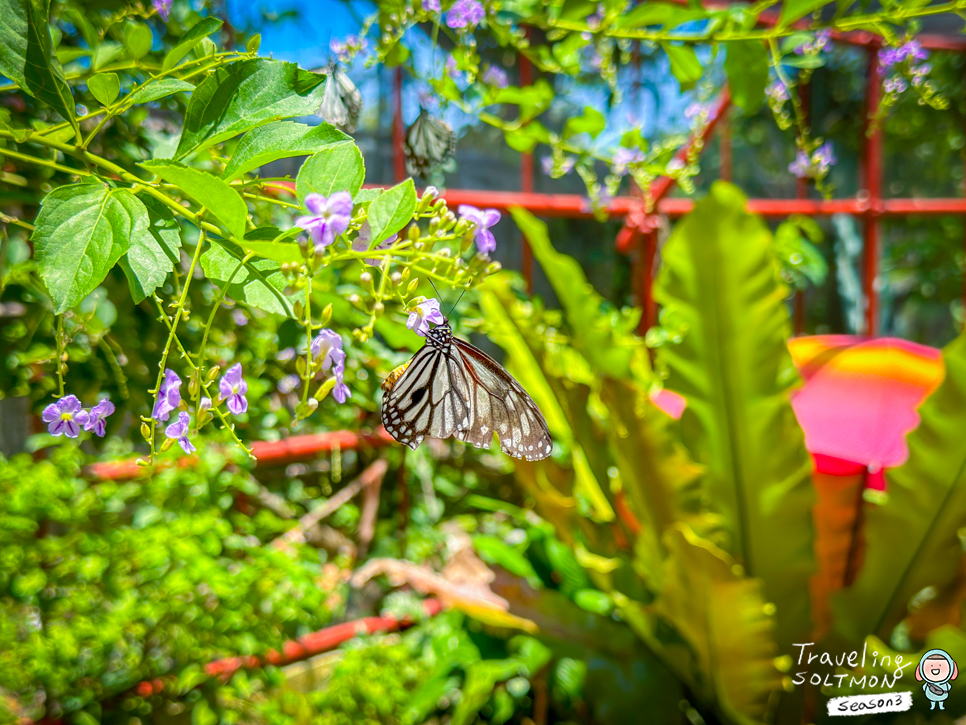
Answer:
[{"xmin": 382, "ymin": 321, "xmax": 553, "ymax": 461}]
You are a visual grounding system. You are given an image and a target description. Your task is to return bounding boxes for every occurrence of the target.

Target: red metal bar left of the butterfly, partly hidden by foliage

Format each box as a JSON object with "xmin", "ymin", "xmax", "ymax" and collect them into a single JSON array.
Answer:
[{"xmin": 87, "ymin": 426, "xmax": 393, "ymax": 481}]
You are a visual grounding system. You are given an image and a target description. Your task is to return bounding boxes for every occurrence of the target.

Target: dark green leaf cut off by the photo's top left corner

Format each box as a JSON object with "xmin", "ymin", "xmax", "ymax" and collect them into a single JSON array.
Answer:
[{"xmin": 0, "ymin": 0, "xmax": 76, "ymax": 129}]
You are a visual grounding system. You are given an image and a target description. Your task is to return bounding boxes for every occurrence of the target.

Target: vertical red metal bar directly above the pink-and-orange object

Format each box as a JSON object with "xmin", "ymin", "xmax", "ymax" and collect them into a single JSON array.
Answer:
[{"xmin": 862, "ymin": 43, "xmax": 882, "ymax": 336}]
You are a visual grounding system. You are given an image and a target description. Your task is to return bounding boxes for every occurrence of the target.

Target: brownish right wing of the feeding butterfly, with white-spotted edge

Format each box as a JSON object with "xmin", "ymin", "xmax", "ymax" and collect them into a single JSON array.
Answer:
[{"xmin": 453, "ymin": 338, "xmax": 553, "ymax": 461}]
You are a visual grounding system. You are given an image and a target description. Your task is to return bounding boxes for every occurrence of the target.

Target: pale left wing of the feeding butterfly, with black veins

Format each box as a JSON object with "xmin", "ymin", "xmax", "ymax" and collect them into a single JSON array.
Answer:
[{"xmin": 382, "ymin": 345, "xmax": 470, "ymax": 450}]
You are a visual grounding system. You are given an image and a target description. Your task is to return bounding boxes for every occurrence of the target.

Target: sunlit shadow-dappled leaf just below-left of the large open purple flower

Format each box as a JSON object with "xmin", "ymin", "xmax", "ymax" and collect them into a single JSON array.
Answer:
[{"xmin": 201, "ymin": 242, "xmax": 295, "ymax": 317}]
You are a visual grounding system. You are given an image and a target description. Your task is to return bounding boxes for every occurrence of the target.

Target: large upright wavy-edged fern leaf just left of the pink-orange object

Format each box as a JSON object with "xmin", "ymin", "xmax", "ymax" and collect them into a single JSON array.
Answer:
[{"xmin": 654, "ymin": 181, "xmax": 814, "ymax": 651}]
